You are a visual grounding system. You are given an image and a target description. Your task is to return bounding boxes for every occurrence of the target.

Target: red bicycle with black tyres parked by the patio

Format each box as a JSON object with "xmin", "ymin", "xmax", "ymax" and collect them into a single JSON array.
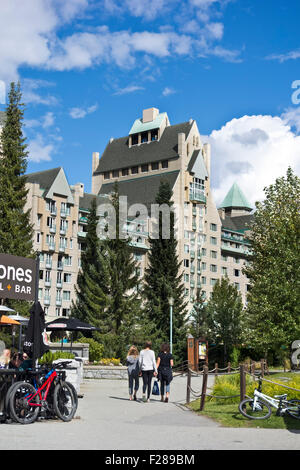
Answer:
[{"xmin": 8, "ymin": 361, "xmax": 78, "ymax": 424}]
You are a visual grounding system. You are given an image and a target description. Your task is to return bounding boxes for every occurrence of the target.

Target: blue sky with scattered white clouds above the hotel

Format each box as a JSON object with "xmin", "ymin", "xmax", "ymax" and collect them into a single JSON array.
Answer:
[{"xmin": 0, "ymin": 0, "xmax": 300, "ymax": 204}]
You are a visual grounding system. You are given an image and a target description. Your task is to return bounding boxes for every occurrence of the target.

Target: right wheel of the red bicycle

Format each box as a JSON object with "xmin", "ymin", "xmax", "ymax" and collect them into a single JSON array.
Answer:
[{"xmin": 53, "ymin": 382, "xmax": 77, "ymax": 421}]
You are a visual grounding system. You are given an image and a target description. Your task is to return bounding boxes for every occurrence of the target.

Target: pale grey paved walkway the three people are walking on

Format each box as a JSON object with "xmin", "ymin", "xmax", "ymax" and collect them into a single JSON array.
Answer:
[{"xmin": 0, "ymin": 377, "xmax": 300, "ymax": 450}]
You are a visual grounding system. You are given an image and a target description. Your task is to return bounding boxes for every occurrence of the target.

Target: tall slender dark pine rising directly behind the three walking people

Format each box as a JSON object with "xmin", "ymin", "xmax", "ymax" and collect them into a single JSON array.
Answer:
[{"xmin": 144, "ymin": 179, "xmax": 187, "ymax": 362}]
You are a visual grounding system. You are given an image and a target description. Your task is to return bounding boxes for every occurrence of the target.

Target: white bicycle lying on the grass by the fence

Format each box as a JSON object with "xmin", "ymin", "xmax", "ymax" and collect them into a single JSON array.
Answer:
[{"xmin": 239, "ymin": 376, "xmax": 300, "ymax": 419}]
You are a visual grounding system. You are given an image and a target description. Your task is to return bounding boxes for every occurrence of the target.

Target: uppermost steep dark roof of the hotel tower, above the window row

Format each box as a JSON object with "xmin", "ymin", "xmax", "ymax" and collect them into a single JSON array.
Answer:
[{"xmin": 94, "ymin": 122, "xmax": 193, "ymax": 174}]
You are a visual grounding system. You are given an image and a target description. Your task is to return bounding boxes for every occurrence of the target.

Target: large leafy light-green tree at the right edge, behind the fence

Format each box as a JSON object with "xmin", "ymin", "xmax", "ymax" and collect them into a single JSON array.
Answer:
[{"xmin": 245, "ymin": 168, "xmax": 300, "ymax": 354}]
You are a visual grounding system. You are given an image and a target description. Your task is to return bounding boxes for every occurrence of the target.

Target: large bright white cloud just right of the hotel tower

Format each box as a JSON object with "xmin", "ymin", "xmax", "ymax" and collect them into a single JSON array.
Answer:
[{"xmin": 206, "ymin": 111, "xmax": 300, "ymax": 208}]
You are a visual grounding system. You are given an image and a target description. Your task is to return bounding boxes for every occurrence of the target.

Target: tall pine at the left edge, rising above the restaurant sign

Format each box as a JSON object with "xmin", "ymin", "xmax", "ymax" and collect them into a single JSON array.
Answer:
[{"xmin": 0, "ymin": 83, "xmax": 33, "ymax": 257}]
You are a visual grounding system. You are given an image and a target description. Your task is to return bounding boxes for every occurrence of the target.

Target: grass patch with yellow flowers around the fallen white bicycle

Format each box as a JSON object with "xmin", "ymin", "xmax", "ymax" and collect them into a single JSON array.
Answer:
[{"xmin": 187, "ymin": 373, "xmax": 300, "ymax": 430}]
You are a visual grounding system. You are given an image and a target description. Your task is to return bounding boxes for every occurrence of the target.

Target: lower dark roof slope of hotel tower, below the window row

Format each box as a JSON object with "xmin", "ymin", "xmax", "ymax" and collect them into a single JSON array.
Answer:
[{"xmin": 99, "ymin": 170, "xmax": 179, "ymax": 208}]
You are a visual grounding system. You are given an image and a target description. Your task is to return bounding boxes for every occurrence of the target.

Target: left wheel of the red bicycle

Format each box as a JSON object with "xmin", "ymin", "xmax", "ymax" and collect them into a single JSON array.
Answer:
[{"xmin": 9, "ymin": 382, "xmax": 40, "ymax": 424}]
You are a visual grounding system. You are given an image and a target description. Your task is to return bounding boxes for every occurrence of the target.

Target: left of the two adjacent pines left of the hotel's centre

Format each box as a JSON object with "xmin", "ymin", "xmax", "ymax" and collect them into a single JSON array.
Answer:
[{"xmin": 72, "ymin": 199, "xmax": 109, "ymax": 333}]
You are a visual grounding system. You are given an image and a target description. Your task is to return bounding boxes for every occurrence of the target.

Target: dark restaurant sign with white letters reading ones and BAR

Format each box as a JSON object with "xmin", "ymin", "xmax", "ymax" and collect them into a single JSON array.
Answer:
[{"xmin": 0, "ymin": 253, "xmax": 36, "ymax": 300}]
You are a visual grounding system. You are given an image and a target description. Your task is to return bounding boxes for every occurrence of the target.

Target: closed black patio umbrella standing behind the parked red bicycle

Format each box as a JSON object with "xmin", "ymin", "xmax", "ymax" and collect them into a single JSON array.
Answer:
[{"xmin": 23, "ymin": 302, "xmax": 49, "ymax": 366}]
